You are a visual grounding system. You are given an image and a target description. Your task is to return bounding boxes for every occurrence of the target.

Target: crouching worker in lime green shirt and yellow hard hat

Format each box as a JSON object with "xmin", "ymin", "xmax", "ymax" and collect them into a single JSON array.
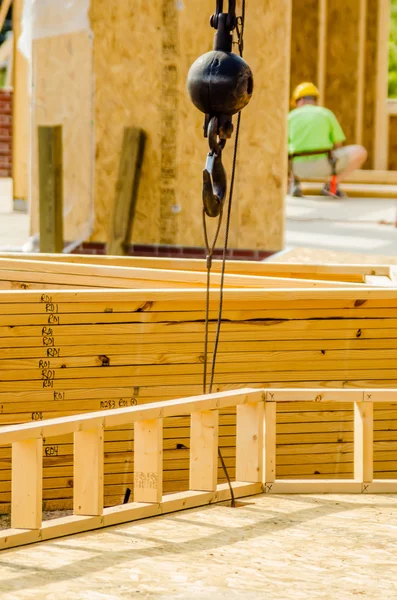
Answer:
[{"xmin": 288, "ymin": 82, "xmax": 367, "ymax": 198}]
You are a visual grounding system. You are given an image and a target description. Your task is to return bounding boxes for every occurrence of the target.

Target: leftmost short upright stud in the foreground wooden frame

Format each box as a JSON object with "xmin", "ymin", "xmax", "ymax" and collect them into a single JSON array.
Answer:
[{"xmin": 11, "ymin": 438, "xmax": 43, "ymax": 529}]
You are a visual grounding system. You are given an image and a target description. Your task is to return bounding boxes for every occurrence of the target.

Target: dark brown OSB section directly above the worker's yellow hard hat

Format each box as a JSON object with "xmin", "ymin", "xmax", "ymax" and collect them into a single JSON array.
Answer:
[{"xmin": 291, "ymin": 0, "xmax": 319, "ymax": 90}]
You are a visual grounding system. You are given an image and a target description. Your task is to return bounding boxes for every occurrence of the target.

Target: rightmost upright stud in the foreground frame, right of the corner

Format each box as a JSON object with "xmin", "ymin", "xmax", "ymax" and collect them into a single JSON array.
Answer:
[{"xmin": 354, "ymin": 402, "xmax": 374, "ymax": 483}]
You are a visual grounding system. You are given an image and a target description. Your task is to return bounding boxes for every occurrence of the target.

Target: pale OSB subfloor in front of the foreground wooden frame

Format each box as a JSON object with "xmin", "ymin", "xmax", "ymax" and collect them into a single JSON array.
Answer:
[{"xmin": 0, "ymin": 495, "xmax": 397, "ymax": 600}]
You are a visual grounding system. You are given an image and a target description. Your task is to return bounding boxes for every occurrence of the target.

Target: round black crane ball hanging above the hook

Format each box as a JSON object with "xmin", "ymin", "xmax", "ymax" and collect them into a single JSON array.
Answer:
[{"xmin": 187, "ymin": 50, "xmax": 254, "ymax": 116}]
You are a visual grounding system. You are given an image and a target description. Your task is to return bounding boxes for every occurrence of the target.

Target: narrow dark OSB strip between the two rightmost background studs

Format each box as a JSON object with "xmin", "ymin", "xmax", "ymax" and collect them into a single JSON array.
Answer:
[{"xmin": 363, "ymin": 0, "xmax": 378, "ymax": 169}]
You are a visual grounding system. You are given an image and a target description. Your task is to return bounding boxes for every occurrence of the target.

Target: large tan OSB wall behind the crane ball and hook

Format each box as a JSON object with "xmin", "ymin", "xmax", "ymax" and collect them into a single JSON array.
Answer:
[{"xmin": 90, "ymin": 0, "xmax": 291, "ymax": 250}]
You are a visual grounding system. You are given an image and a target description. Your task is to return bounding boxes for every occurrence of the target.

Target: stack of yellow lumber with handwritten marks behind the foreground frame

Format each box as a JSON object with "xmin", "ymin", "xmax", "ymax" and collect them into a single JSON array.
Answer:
[{"xmin": 0, "ymin": 255, "xmax": 397, "ymax": 513}]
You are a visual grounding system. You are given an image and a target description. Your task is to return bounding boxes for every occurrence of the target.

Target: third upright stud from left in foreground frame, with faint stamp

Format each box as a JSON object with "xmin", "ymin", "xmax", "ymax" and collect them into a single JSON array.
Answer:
[{"xmin": 134, "ymin": 419, "xmax": 163, "ymax": 502}]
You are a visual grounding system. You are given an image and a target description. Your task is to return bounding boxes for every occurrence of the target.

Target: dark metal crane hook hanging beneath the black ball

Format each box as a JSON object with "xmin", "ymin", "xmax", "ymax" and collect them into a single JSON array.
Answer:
[{"xmin": 203, "ymin": 117, "xmax": 227, "ymax": 217}]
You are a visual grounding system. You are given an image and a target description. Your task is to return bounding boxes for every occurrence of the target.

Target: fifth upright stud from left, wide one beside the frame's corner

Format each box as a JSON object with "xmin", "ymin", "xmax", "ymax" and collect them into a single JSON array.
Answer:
[{"xmin": 236, "ymin": 402, "xmax": 264, "ymax": 483}]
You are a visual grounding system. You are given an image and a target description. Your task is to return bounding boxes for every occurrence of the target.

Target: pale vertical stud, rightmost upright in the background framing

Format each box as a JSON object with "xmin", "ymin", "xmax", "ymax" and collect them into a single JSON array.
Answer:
[{"xmin": 374, "ymin": 0, "xmax": 390, "ymax": 170}]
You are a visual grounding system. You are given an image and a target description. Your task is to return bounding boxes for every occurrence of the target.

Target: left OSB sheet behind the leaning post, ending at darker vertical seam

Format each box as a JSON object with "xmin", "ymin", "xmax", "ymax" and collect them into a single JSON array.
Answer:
[{"xmin": 90, "ymin": 0, "xmax": 162, "ymax": 244}]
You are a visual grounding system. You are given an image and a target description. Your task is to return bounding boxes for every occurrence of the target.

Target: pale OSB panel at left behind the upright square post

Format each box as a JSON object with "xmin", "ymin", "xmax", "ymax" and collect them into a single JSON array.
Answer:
[{"xmin": 31, "ymin": 31, "xmax": 94, "ymax": 242}]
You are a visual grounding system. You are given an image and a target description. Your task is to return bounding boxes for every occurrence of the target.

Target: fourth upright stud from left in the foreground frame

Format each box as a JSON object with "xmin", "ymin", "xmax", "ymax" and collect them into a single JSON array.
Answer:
[{"xmin": 189, "ymin": 410, "xmax": 219, "ymax": 492}]
